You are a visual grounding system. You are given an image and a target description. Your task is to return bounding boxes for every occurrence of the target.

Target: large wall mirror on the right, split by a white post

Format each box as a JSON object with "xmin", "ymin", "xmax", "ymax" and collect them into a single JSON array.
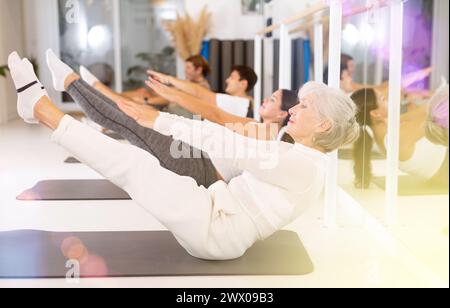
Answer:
[{"xmin": 339, "ymin": 0, "xmax": 449, "ymax": 281}]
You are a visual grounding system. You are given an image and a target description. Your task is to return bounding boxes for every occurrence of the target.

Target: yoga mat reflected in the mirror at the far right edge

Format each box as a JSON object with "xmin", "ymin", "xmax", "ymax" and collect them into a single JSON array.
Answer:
[{"xmin": 372, "ymin": 175, "xmax": 449, "ymax": 197}]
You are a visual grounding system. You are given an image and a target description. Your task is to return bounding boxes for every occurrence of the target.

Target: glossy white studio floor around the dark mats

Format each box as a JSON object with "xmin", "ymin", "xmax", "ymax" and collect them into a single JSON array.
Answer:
[{"xmin": 0, "ymin": 121, "xmax": 449, "ymax": 288}]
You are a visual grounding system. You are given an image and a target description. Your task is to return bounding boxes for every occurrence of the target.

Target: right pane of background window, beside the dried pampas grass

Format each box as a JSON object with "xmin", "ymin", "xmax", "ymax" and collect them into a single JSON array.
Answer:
[{"xmin": 120, "ymin": 0, "xmax": 182, "ymax": 91}]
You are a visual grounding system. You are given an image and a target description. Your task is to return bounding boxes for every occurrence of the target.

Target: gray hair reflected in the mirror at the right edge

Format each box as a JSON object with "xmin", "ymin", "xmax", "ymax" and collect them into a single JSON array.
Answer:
[{"xmin": 425, "ymin": 84, "xmax": 449, "ymax": 147}]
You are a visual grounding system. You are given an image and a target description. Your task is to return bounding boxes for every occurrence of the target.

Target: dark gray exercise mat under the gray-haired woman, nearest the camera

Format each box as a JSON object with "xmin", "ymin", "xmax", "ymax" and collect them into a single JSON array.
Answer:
[{"xmin": 0, "ymin": 231, "xmax": 314, "ymax": 279}]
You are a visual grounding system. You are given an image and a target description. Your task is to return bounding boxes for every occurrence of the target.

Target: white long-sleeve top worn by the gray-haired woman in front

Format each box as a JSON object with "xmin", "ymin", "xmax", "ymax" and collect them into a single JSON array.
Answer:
[{"xmin": 154, "ymin": 113, "xmax": 328, "ymax": 239}]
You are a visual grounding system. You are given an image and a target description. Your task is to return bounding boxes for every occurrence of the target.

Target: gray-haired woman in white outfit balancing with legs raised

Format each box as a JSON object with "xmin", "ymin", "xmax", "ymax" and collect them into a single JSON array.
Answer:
[{"xmin": 9, "ymin": 54, "xmax": 360, "ymax": 260}]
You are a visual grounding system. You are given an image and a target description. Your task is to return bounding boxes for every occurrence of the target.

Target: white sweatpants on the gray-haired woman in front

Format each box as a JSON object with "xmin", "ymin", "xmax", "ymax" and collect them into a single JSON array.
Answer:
[{"xmin": 52, "ymin": 116, "xmax": 259, "ymax": 260}]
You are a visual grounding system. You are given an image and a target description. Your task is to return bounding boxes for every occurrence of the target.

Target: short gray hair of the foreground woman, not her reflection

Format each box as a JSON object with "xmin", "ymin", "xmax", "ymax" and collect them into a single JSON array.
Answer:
[{"xmin": 299, "ymin": 82, "xmax": 361, "ymax": 152}]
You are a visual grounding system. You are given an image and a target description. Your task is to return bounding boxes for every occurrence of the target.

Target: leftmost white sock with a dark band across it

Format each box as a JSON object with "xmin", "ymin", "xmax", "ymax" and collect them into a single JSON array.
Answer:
[{"xmin": 8, "ymin": 52, "xmax": 48, "ymax": 124}]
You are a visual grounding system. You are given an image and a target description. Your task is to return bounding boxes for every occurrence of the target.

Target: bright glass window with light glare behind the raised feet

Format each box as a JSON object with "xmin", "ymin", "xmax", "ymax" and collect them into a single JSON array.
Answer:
[{"xmin": 58, "ymin": 0, "xmax": 183, "ymax": 102}]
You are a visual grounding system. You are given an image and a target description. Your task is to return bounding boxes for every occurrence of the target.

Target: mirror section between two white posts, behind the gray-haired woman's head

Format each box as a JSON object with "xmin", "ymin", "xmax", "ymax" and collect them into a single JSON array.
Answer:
[{"xmin": 336, "ymin": 1, "xmax": 390, "ymax": 201}]
